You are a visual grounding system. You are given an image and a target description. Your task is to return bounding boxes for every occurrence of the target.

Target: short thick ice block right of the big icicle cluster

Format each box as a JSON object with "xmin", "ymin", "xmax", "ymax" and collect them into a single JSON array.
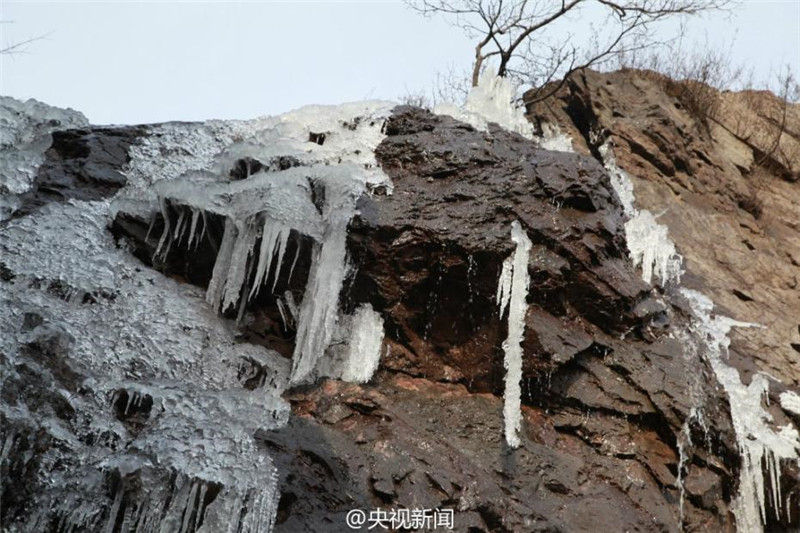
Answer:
[{"xmin": 342, "ymin": 304, "xmax": 383, "ymax": 383}]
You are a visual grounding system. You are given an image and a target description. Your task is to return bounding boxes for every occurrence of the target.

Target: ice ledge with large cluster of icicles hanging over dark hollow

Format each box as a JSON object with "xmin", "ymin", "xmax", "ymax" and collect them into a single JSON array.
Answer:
[{"xmin": 150, "ymin": 161, "xmax": 383, "ymax": 384}]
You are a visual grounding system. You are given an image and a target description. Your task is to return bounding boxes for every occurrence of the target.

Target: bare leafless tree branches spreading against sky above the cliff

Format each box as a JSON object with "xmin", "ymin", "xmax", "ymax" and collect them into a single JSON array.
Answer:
[{"xmin": 408, "ymin": 0, "xmax": 729, "ymax": 103}]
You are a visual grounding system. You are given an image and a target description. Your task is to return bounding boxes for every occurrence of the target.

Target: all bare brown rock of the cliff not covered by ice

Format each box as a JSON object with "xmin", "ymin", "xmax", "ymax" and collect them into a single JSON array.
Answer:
[{"xmin": 6, "ymin": 73, "xmax": 800, "ymax": 532}]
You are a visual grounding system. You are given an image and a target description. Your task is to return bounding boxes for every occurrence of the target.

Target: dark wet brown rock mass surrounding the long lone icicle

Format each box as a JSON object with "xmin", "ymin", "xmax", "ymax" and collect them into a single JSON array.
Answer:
[{"xmin": 104, "ymin": 108, "xmax": 752, "ymax": 531}]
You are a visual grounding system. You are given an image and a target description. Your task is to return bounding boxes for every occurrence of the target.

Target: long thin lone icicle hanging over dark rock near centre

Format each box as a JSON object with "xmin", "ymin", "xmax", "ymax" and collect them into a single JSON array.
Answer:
[{"xmin": 497, "ymin": 220, "xmax": 531, "ymax": 448}]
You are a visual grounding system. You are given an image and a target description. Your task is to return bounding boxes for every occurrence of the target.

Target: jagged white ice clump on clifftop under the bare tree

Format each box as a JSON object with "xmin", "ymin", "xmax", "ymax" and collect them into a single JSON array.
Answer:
[{"xmin": 433, "ymin": 68, "xmax": 534, "ymax": 139}]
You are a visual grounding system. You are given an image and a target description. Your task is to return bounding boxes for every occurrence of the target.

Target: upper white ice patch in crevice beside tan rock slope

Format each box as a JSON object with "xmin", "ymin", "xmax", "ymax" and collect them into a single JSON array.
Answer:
[{"xmin": 600, "ymin": 139, "xmax": 683, "ymax": 286}]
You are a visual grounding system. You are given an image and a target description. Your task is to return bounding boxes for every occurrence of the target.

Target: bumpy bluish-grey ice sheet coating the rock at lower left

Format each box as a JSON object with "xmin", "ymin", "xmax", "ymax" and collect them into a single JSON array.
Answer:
[{"xmin": 0, "ymin": 201, "xmax": 289, "ymax": 532}]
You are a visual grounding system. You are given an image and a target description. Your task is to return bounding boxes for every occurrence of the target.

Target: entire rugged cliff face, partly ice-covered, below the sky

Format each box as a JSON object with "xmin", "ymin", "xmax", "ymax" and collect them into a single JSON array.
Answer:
[{"xmin": 0, "ymin": 72, "xmax": 800, "ymax": 532}]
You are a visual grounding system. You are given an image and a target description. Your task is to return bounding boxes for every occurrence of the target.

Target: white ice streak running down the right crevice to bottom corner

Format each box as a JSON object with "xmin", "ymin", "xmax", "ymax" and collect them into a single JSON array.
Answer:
[{"xmin": 600, "ymin": 134, "xmax": 800, "ymax": 533}]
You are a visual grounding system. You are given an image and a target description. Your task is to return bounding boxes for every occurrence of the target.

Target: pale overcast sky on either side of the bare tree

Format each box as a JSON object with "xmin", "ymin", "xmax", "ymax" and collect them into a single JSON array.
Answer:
[{"xmin": 0, "ymin": 0, "xmax": 800, "ymax": 124}]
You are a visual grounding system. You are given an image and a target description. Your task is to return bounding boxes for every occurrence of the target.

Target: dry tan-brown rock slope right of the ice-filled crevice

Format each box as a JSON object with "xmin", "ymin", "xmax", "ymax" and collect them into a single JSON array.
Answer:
[{"xmin": 529, "ymin": 71, "xmax": 800, "ymax": 393}]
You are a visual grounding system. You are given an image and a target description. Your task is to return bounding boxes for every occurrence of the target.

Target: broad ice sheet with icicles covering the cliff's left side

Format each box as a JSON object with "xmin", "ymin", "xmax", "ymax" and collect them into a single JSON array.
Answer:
[{"xmin": 0, "ymin": 97, "xmax": 392, "ymax": 533}]
